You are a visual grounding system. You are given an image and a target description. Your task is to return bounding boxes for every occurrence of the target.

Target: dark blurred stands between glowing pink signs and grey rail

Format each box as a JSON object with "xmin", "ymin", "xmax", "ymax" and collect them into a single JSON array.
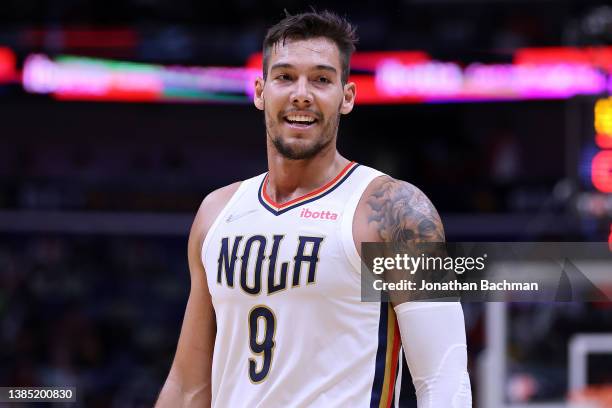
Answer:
[{"xmin": 0, "ymin": 101, "xmax": 572, "ymax": 217}]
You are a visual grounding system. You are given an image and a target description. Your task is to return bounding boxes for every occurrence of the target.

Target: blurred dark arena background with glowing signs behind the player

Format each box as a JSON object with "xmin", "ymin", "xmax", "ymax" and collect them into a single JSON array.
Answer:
[{"xmin": 0, "ymin": 0, "xmax": 612, "ymax": 408}]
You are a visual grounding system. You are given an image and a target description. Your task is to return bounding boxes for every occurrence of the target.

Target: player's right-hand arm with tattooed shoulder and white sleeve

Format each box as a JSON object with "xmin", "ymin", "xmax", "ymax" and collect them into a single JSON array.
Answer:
[{"xmin": 353, "ymin": 176, "xmax": 472, "ymax": 408}]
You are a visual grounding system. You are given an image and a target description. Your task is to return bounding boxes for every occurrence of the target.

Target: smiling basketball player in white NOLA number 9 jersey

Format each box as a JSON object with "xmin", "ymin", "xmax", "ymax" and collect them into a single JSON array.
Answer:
[{"xmin": 157, "ymin": 12, "xmax": 471, "ymax": 408}]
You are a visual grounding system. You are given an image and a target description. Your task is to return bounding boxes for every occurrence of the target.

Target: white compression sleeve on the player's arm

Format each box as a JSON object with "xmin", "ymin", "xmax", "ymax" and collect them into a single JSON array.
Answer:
[{"xmin": 394, "ymin": 302, "xmax": 472, "ymax": 408}]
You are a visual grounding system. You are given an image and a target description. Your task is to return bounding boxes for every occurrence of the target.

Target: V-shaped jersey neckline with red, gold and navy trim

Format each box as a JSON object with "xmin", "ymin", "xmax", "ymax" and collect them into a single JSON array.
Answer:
[{"xmin": 258, "ymin": 162, "xmax": 359, "ymax": 215}]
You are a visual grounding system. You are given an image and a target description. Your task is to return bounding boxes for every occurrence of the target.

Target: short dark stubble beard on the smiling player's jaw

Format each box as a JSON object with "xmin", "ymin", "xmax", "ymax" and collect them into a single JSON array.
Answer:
[{"xmin": 265, "ymin": 112, "xmax": 340, "ymax": 160}]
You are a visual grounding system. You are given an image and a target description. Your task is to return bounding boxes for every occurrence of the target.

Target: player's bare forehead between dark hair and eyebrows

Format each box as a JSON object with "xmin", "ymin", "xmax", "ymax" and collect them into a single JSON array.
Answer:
[{"xmin": 269, "ymin": 37, "xmax": 341, "ymax": 72}]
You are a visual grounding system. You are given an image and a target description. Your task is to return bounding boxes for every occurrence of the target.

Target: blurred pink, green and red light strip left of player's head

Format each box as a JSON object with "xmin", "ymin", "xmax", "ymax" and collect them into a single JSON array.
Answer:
[{"xmin": 23, "ymin": 54, "xmax": 253, "ymax": 102}]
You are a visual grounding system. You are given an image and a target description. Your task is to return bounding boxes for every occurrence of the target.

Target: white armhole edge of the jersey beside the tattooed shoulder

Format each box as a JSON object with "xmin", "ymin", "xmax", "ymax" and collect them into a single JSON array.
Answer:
[{"xmin": 340, "ymin": 169, "xmax": 384, "ymax": 278}]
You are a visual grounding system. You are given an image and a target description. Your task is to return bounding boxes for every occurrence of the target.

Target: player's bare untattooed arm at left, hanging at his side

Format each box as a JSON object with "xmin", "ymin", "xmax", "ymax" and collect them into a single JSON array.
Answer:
[{"xmin": 155, "ymin": 183, "xmax": 239, "ymax": 408}]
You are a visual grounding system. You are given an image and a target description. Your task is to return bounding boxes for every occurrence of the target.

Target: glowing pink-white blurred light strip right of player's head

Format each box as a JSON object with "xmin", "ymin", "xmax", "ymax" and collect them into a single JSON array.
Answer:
[{"xmin": 375, "ymin": 60, "xmax": 607, "ymax": 102}]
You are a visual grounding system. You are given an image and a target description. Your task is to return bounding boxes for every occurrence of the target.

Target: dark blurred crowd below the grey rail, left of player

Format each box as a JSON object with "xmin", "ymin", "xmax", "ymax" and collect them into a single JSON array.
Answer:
[{"xmin": 0, "ymin": 235, "xmax": 189, "ymax": 408}]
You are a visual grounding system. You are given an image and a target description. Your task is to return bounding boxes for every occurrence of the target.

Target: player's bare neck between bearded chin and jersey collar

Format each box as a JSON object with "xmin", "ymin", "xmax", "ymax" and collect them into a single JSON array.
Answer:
[{"xmin": 266, "ymin": 140, "xmax": 349, "ymax": 203}]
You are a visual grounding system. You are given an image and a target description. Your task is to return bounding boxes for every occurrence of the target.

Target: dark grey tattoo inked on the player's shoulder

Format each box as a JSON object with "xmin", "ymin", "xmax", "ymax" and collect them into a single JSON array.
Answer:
[{"xmin": 367, "ymin": 177, "xmax": 444, "ymax": 243}]
